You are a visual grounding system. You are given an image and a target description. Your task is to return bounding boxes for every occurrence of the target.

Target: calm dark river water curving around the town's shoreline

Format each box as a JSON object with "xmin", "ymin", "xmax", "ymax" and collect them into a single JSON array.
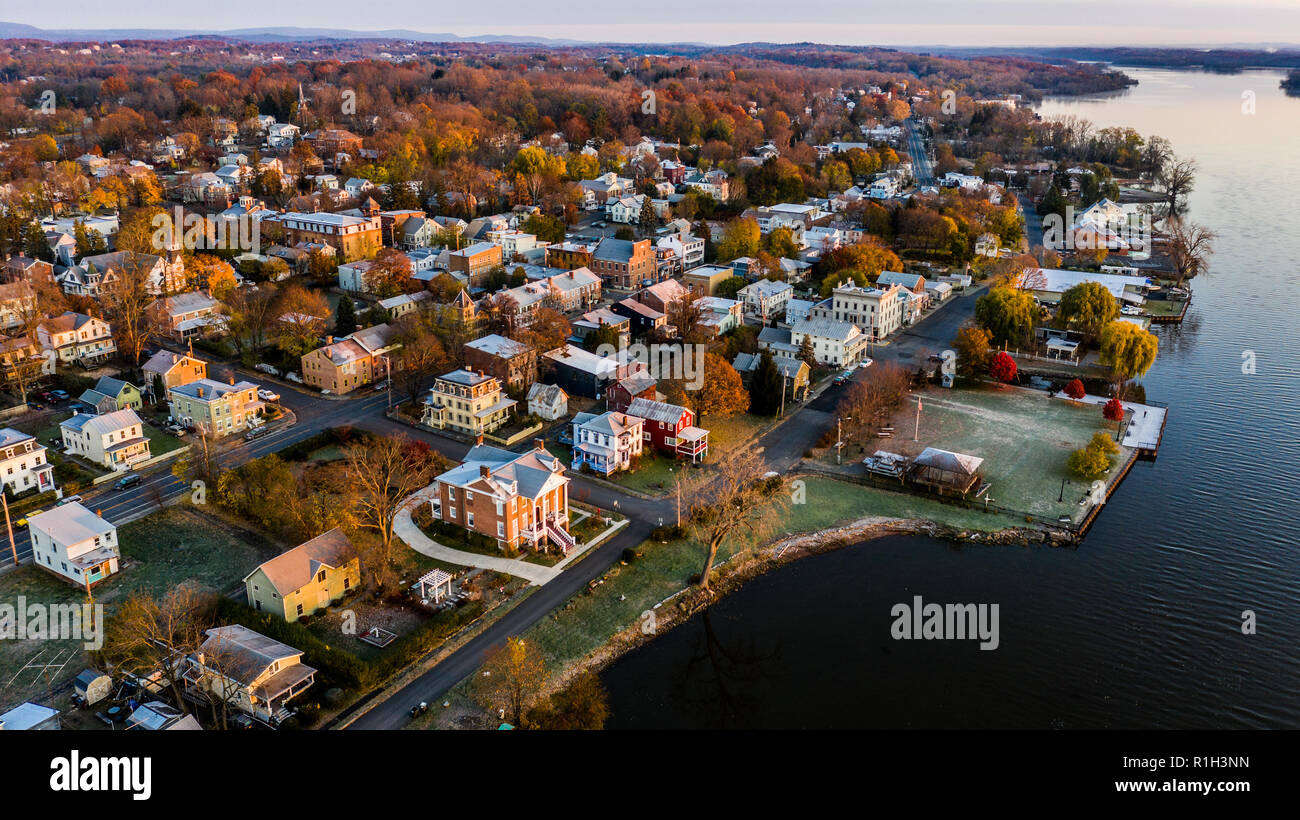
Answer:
[{"xmin": 603, "ymin": 69, "xmax": 1300, "ymax": 728}]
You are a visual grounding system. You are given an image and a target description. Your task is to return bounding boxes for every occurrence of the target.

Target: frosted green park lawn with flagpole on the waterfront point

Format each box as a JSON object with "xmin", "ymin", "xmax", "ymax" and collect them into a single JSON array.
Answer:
[{"xmin": 823, "ymin": 386, "xmax": 1128, "ymax": 522}]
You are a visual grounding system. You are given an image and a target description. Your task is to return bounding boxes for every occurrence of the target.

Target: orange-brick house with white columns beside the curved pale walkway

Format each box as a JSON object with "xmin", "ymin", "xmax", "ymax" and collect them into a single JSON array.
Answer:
[{"xmin": 433, "ymin": 439, "xmax": 576, "ymax": 552}]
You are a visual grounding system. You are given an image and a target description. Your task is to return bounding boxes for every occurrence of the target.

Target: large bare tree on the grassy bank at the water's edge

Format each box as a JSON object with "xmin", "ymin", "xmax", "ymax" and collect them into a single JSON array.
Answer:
[{"xmin": 683, "ymin": 447, "xmax": 789, "ymax": 591}]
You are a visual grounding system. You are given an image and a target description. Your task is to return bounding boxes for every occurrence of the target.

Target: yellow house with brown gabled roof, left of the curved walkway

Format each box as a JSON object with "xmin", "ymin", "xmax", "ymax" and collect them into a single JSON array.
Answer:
[{"xmin": 244, "ymin": 528, "xmax": 361, "ymax": 621}]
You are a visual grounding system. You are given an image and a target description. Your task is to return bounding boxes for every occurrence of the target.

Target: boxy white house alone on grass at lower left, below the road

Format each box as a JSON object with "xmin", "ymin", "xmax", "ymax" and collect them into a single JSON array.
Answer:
[{"xmin": 27, "ymin": 502, "xmax": 121, "ymax": 589}]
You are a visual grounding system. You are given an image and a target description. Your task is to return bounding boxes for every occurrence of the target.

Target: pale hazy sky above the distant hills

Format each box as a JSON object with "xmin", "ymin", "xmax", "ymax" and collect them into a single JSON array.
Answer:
[{"xmin": 0, "ymin": 0, "xmax": 1300, "ymax": 45}]
